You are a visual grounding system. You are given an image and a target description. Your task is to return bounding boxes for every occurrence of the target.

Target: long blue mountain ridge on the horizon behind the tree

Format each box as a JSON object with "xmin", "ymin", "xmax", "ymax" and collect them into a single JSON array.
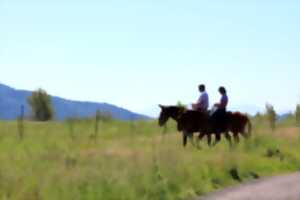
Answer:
[{"xmin": 0, "ymin": 84, "xmax": 150, "ymax": 120}]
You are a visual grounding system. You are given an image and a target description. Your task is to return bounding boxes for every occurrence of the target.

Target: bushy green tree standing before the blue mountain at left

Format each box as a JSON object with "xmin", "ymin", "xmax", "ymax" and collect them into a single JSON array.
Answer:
[{"xmin": 27, "ymin": 89, "xmax": 54, "ymax": 121}]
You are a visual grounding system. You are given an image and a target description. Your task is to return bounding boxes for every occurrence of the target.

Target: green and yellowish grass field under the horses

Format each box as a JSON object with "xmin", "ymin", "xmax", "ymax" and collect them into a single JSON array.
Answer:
[{"xmin": 0, "ymin": 119, "xmax": 300, "ymax": 200}]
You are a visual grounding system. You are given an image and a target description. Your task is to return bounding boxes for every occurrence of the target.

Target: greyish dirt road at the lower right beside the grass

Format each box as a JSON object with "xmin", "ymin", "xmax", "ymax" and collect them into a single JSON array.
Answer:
[{"xmin": 196, "ymin": 172, "xmax": 300, "ymax": 200}]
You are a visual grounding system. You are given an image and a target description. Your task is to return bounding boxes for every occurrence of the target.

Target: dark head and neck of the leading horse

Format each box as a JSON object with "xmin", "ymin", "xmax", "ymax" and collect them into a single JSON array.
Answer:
[{"xmin": 158, "ymin": 105, "xmax": 185, "ymax": 126}]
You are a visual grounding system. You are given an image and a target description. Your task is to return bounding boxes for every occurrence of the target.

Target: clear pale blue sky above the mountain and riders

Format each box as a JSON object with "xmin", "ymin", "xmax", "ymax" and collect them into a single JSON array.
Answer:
[{"xmin": 0, "ymin": 0, "xmax": 300, "ymax": 116}]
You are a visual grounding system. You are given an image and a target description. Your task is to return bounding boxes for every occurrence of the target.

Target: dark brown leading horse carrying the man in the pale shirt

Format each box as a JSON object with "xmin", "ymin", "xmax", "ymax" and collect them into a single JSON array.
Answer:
[{"xmin": 158, "ymin": 105, "xmax": 231, "ymax": 146}]
